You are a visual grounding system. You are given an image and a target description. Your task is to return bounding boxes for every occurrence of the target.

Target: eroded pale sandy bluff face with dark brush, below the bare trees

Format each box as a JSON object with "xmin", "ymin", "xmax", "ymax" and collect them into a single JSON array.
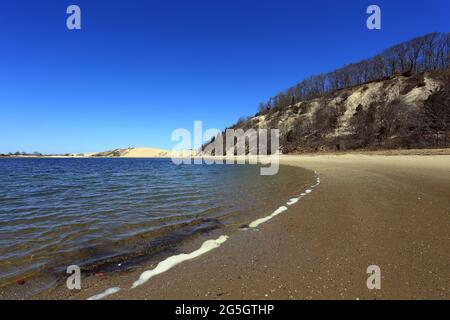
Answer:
[{"xmin": 216, "ymin": 71, "xmax": 450, "ymax": 153}]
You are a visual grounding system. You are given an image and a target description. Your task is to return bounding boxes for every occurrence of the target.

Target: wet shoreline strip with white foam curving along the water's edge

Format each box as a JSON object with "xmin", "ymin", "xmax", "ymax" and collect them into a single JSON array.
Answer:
[{"xmin": 32, "ymin": 162, "xmax": 320, "ymax": 300}]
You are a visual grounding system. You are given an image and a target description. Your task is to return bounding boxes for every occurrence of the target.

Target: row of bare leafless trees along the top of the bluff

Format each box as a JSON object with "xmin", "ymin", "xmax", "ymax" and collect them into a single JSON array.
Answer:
[{"xmin": 258, "ymin": 32, "xmax": 450, "ymax": 114}]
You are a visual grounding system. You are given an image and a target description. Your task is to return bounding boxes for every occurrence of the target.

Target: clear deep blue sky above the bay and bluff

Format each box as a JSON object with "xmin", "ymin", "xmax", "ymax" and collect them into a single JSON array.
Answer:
[{"xmin": 0, "ymin": 0, "xmax": 450, "ymax": 153}]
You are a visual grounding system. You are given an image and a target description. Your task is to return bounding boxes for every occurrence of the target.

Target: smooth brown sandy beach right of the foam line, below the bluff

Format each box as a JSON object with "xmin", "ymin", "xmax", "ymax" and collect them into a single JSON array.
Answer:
[{"xmin": 37, "ymin": 154, "xmax": 450, "ymax": 299}]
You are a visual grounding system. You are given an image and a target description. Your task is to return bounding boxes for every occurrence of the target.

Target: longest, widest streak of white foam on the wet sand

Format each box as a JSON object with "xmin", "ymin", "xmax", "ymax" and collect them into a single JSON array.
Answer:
[{"xmin": 131, "ymin": 236, "xmax": 228, "ymax": 288}]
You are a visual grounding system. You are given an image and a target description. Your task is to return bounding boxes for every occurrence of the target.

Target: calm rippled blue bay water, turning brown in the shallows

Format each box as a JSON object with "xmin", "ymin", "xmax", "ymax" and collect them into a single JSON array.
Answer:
[{"xmin": 0, "ymin": 159, "xmax": 312, "ymax": 294}]
